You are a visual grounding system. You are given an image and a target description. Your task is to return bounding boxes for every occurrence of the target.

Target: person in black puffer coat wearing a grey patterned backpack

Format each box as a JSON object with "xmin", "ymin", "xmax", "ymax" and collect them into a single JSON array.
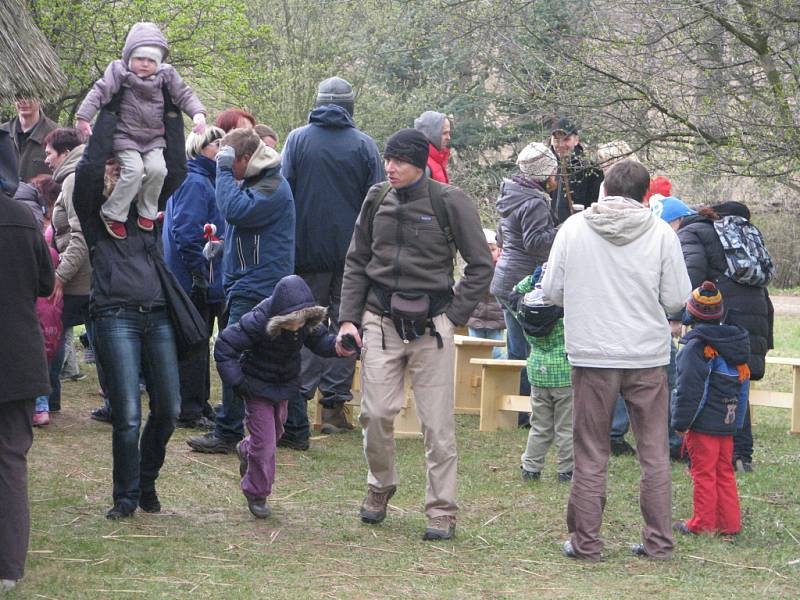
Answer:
[{"xmin": 678, "ymin": 202, "xmax": 773, "ymax": 472}]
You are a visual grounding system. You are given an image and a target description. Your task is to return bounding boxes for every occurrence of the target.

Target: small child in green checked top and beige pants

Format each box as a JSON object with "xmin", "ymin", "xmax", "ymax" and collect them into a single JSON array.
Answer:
[{"xmin": 514, "ymin": 263, "xmax": 575, "ymax": 482}]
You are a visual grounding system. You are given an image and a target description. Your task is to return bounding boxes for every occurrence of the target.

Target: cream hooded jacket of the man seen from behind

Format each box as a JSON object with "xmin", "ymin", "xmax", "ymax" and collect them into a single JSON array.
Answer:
[{"xmin": 542, "ymin": 196, "xmax": 692, "ymax": 369}]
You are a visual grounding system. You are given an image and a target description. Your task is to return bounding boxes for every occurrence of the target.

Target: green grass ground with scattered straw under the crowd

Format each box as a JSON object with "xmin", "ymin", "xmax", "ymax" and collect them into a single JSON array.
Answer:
[{"xmin": 8, "ymin": 318, "xmax": 800, "ymax": 600}]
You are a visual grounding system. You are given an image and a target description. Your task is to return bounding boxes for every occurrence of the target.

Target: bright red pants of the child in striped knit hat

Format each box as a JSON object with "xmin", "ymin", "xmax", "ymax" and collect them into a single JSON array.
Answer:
[{"xmin": 686, "ymin": 431, "xmax": 742, "ymax": 534}]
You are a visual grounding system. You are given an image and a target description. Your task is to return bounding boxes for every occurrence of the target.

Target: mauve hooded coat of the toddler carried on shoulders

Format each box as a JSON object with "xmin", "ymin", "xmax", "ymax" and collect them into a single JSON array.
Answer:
[{"xmin": 76, "ymin": 23, "xmax": 206, "ymax": 154}]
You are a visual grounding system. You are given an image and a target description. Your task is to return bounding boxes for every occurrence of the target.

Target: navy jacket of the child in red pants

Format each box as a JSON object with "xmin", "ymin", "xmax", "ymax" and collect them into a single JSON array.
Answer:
[{"xmin": 672, "ymin": 325, "xmax": 750, "ymax": 435}]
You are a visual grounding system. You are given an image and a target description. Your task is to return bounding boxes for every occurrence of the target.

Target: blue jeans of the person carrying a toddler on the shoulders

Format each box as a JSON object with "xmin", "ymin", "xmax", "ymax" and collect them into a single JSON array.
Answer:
[{"xmin": 94, "ymin": 308, "xmax": 181, "ymax": 508}]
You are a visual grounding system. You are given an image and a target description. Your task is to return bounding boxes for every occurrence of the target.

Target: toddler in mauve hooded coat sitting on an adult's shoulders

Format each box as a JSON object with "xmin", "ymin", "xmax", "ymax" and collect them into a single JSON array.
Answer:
[{"xmin": 76, "ymin": 23, "xmax": 206, "ymax": 240}]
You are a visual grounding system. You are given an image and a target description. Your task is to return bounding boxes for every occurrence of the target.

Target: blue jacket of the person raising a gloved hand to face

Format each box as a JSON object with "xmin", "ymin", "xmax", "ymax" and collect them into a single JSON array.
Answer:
[{"xmin": 217, "ymin": 156, "xmax": 294, "ymax": 302}]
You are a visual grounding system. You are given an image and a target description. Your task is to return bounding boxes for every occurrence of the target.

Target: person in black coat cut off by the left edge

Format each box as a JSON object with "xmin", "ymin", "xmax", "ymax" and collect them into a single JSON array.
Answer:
[{"xmin": 0, "ymin": 194, "xmax": 54, "ymax": 592}]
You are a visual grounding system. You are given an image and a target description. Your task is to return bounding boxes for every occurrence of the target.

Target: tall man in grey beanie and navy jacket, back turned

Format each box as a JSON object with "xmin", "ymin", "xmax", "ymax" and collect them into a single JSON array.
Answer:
[{"xmin": 279, "ymin": 77, "xmax": 385, "ymax": 450}]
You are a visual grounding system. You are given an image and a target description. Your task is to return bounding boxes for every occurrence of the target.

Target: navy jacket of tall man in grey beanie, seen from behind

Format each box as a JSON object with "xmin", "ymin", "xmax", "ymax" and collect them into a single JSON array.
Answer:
[{"xmin": 281, "ymin": 104, "xmax": 385, "ymax": 273}]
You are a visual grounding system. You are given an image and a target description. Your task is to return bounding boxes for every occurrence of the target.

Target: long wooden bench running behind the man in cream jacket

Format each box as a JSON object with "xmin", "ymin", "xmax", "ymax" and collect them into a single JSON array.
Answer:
[{"xmin": 471, "ymin": 356, "xmax": 800, "ymax": 434}]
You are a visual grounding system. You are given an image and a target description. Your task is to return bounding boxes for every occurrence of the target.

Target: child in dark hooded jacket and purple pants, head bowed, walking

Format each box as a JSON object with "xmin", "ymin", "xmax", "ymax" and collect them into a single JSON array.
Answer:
[{"xmin": 214, "ymin": 275, "xmax": 352, "ymax": 519}]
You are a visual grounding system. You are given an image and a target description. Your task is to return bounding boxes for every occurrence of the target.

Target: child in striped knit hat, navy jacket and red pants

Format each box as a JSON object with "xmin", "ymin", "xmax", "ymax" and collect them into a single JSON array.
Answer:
[{"xmin": 672, "ymin": 281, "xmax": 750, "ymax": 535}]
